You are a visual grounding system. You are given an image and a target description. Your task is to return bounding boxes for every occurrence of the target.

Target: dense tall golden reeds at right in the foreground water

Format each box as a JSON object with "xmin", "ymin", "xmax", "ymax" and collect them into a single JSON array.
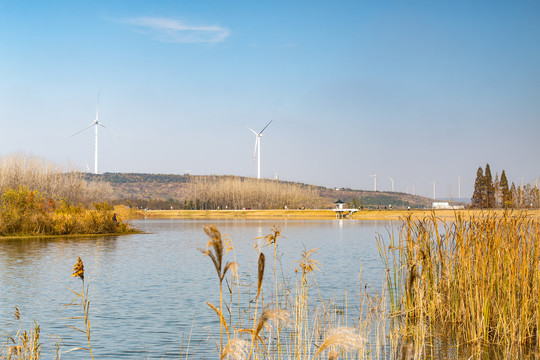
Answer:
[{"xmin": 379, "ymin": 212, "xmax": 540, "ymax": 350}]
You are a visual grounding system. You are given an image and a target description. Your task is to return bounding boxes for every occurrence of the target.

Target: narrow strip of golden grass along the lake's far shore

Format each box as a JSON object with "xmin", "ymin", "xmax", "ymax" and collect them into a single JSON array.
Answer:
[{"xmin": 135, "ymin": 210, "xmax": 540, "ymax": 220}]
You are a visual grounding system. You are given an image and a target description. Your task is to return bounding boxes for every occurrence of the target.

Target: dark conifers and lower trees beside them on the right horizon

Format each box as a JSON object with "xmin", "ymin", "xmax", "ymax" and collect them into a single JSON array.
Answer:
[{"xmin": 471, "ymin": 164, "xmax": 540, "ymax": 209}]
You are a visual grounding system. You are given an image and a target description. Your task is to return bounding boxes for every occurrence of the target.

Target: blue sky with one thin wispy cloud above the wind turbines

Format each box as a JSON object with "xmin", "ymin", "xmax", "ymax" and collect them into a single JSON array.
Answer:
[{"xmin": 0, "ymin": 0, "xmax": 540, "ymax": 197}]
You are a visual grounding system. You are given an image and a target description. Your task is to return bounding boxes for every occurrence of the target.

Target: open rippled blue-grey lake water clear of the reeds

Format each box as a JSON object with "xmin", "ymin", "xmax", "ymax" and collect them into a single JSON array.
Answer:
[{"xmin": 0, "ymin": 220, "xmax": 398, "ymax": 359}]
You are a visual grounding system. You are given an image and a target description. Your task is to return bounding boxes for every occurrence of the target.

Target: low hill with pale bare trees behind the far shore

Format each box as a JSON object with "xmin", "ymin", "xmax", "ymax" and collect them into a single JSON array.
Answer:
[{"xmin": 84, "ymin": 173, "xmax": 431, "ymax": 209}]
